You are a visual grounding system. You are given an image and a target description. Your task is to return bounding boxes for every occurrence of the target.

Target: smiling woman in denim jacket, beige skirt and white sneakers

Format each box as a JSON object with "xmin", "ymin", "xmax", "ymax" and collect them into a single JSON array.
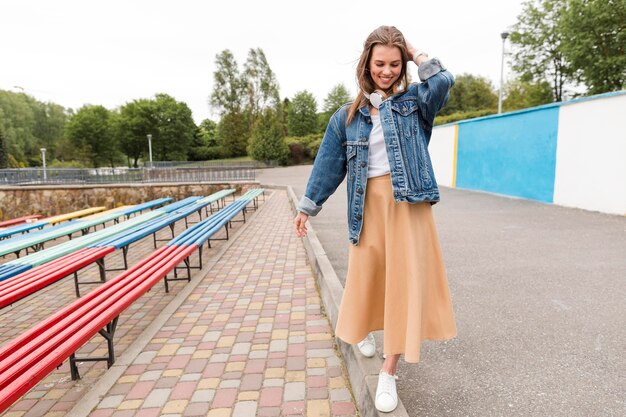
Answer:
[{"xmin": 294, "ymin": 26, "xmax": 456, "ymax": 412}]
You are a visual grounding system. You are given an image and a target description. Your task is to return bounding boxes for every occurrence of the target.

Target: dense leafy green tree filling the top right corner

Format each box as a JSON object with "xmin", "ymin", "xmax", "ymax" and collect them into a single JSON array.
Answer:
[{"xmin": 560, "ymin": 0, "xmax": 626, "ymax": 94}]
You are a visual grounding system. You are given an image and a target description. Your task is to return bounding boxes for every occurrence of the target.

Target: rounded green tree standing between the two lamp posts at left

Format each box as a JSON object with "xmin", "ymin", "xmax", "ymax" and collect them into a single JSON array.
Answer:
[{"xmin": 66, "ymin": 105, "xmax": 119, "ymax": 167}]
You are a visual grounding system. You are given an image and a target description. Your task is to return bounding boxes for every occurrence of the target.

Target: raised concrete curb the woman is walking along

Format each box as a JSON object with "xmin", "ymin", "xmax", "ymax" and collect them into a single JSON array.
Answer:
[{"xmin": 276, "ymin": 184, "xmax": 408, "ymax": 417}]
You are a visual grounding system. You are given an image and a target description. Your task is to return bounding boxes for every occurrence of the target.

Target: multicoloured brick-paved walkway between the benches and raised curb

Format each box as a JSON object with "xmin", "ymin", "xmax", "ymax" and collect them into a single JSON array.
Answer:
[{"xmin": 1, "ymin": 190, "xmax": 356, "ymax": 417}]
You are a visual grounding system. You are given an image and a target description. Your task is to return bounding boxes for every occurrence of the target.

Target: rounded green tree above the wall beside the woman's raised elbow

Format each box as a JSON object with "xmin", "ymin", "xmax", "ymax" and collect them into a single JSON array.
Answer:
[{"xmin": 439, "ymin": 74, "xmax": 498, "ymax": 116}]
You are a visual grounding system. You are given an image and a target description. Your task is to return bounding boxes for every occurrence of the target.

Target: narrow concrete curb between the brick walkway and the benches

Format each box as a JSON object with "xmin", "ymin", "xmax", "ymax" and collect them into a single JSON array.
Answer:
[{"xmin": 66, "ymin": 191, "xmax": 272, "ymax": 417}]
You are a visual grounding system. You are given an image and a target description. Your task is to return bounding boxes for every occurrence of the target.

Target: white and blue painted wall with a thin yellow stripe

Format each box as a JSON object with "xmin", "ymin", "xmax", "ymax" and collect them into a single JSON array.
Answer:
[{"xmin": 429, "ymin": 91, "xmax": 626, "ymax": 215}]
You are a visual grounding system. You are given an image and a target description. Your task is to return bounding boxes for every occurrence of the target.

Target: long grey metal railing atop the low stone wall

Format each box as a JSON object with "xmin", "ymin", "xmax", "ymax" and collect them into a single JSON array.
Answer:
[{"xmin": 0, "ymin": 162, "xmax": 256, "ymax": 186}]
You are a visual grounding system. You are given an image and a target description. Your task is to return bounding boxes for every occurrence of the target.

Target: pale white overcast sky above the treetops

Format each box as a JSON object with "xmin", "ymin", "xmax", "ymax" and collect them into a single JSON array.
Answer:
[{"xmin": 0, "ymin": 0, "xmax": 522, "ymax": 123}]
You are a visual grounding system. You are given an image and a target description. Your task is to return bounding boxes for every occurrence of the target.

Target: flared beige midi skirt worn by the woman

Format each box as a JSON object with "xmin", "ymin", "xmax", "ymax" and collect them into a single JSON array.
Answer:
[{"xmin": 335, "ymin": 175, "xmax": 456, "ymax": 363}]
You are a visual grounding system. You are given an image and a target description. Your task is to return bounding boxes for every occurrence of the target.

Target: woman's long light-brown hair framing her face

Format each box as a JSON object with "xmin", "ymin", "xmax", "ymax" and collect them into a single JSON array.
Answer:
[{"xmin": 346, "ymin": 26, "xmax": 410, "ymax": 125}]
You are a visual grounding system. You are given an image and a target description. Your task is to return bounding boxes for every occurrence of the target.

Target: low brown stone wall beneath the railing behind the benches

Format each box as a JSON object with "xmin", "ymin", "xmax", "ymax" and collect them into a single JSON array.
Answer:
[{"xmin": 0, "ymin": 181, "xmax": 259, "ymax": 220}]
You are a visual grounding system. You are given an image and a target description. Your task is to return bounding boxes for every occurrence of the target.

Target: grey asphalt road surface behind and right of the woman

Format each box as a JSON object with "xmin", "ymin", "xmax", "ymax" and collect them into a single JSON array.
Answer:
[{"xmin": 257, "ymin": 166, "xmax": 626, "ymax": 417}]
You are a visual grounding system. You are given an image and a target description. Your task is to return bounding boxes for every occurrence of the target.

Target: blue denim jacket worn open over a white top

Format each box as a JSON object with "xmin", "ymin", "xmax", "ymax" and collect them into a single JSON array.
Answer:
[{"xmin": 297, "ymin": 58, "xmax": 454, "ymax": 245}]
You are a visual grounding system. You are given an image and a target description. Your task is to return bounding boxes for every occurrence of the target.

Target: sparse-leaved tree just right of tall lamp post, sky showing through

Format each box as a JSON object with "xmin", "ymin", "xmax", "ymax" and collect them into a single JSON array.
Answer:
[{"xmin": 511, "ymin": 0, "xmax": 574, "ymax": 101}]
